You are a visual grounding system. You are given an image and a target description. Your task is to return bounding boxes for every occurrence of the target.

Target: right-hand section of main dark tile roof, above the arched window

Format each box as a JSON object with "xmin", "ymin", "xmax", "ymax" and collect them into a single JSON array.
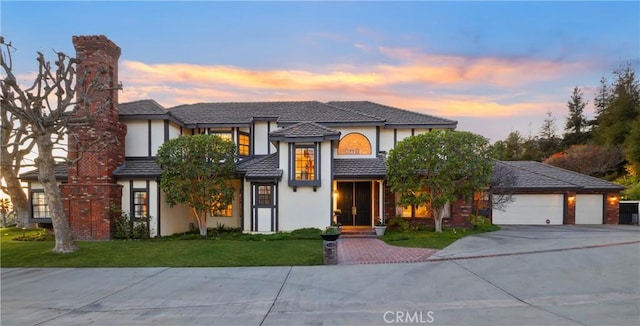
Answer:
[{"xmin": 327, "ymin": 101, "xmax": 458, "ymax": 128}]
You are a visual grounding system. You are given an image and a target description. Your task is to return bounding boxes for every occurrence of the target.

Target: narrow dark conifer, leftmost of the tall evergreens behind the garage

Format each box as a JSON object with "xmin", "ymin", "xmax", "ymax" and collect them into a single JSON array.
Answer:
[{"xmin": 563, "ymin": 87, "xmax": 589, "ymax": 147}]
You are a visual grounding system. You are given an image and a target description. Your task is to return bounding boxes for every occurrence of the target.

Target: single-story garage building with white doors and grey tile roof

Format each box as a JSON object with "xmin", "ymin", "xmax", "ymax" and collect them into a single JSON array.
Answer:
[{"xmin": 491, "ymin": 161, "xmax": 624, "ymax": 225}]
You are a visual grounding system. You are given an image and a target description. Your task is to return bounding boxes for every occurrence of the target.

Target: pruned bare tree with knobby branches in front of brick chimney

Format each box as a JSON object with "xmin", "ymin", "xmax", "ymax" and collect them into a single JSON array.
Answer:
[{"xmin": 0, "ymin": 37, "xmax": 119, "ymax": 253}]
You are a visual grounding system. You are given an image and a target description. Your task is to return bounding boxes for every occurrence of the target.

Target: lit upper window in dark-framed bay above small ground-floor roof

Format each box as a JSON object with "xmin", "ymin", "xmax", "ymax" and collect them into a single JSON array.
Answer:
[{"xmin": 289, "ymin": 143, "xmax": 320, "ymax": 187}]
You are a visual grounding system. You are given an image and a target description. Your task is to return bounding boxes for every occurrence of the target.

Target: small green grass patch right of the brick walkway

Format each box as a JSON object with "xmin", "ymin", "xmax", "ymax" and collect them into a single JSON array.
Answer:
[{"xmin": 382, "ymin": 225, "xmax": 500, "ymax": 249}]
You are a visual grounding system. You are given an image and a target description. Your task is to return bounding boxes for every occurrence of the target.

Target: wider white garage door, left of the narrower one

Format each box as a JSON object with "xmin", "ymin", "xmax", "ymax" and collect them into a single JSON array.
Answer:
[{"xmin": 492, "ymin": 195, "xmax": 564, "ymax": 225}]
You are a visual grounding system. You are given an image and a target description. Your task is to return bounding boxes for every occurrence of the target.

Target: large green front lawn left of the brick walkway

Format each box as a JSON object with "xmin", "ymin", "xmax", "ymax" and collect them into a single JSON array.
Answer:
[{"xmin": 0, "ymin": 228, "xmax": 322, "ymax": 268}]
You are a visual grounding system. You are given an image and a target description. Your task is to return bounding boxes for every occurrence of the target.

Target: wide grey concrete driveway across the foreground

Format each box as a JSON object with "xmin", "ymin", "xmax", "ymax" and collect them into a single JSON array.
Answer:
[{"xmin": 1, "ymin": 226, "xmax": 640, "ymax": 326}]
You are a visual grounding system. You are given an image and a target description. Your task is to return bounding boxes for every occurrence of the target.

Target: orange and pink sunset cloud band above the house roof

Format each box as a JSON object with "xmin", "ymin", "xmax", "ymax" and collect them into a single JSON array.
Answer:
[{"xmin": 120, "ymin": 45, "xmax": 589, "ymax": 117}]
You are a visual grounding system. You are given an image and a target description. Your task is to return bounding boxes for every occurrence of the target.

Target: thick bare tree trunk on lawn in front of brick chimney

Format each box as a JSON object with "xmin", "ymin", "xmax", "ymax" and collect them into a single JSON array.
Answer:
[{"xmin": 36, "ymin": 133, "xmax": 78, "ymax": 253}]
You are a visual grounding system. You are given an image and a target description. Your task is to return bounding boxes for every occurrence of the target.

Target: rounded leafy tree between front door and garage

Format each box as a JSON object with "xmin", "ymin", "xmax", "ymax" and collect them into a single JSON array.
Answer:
[{"xmin": 387, "ymin": 130, "xmax": 493, "ymax": 232}]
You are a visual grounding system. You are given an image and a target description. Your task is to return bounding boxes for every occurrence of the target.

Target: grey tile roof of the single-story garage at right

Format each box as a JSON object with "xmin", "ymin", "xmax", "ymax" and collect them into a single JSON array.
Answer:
[{"xmin": 497, "ymin": 161, "xmax": 624, "ymax": 191}]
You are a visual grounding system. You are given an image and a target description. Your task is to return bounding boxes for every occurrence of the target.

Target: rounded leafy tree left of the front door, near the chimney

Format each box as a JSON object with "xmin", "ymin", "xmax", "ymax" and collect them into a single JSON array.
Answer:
[{"xmin": 157, "ymin": 134, "xmax": 236, "ymax": 237}]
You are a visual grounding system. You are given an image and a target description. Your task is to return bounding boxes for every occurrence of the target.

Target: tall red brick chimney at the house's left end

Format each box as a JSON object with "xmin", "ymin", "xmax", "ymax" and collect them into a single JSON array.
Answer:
[{"xmin": 61, "ymin": 35, "xmax": 127, "ymax": 240}]
